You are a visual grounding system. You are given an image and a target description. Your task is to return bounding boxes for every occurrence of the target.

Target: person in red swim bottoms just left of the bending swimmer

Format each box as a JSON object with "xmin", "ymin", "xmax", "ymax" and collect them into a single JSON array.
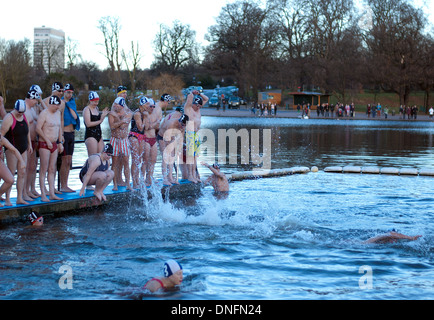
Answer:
[{"xmin": 141, "ymin": 99, "xmax": 160, "ymax": 187}]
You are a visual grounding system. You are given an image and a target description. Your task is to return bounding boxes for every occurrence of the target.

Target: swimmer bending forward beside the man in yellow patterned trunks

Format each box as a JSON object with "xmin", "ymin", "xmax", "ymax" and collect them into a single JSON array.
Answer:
[{"xmin": 157, "ymin": 108, "xmax": 188, "ymax": 186}]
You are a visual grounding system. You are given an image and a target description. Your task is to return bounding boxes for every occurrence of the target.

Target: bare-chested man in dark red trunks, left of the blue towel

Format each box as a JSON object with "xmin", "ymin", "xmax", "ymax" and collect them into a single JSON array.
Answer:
[{"xmin": 36, "ymin": 96, "xmax": 63, "ymax": 202}]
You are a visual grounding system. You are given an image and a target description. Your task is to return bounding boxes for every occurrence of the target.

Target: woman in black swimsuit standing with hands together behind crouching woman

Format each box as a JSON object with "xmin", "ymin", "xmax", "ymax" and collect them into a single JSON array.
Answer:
[{"xmin": 83, "ymin": 92, "xmax": 109, "ymax": 156}]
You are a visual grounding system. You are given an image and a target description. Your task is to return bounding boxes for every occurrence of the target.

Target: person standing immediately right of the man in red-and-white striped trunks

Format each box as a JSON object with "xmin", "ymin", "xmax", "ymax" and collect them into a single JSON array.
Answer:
[{"xmin": 128, "ymin": 97, "xmax": 148, "ymax": 189}]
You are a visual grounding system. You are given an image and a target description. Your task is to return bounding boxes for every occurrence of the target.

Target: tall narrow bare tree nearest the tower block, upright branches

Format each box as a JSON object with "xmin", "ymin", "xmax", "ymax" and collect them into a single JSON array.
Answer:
[{"xmin": 98, "ymin": 16, "xmax": 122, "ymax": 86}]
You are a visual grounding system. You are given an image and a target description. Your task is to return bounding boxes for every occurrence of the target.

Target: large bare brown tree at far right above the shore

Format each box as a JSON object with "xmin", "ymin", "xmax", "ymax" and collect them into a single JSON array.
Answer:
[{"xmin": 365, "ymin": 0, "xmax": 426, "ymax": 105}]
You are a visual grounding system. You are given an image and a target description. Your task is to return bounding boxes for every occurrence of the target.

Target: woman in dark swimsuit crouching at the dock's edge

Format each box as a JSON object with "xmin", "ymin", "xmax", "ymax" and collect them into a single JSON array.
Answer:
[{"xmin": 80, "ymin": 144, "xmax": 115, "ymax": 201}]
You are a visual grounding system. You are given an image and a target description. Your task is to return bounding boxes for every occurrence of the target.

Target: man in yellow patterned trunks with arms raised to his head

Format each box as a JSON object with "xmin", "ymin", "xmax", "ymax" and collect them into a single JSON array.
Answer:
[{"xmin": 184, "ymin": 90, "xmax": 208, "ymax": 183}]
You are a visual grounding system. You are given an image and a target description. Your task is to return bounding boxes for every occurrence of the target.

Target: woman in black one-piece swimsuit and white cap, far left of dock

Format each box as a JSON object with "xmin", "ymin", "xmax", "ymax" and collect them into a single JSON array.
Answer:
[{"xmin": 1, "ymin": 100, "xmax": 33, "ymax": 206}]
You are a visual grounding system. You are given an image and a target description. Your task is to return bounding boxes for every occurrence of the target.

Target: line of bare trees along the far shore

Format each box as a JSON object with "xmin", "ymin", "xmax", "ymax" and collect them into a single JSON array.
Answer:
[{"xmin": 0, "ymin": 0, "xmax": 434, "ymax": 110}]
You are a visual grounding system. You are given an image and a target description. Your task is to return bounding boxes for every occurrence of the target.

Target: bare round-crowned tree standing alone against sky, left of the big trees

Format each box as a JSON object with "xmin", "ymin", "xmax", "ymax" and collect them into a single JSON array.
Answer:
[{"xmin": 152, "ymin": 20, "xmax": 198, "ymax": 74}]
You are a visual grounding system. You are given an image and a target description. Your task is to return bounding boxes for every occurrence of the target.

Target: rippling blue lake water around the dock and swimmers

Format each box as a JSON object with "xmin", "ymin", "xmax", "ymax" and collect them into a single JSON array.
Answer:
[{"xmin": 0, "ymin": 117, "xmax": 434, "ymax": 300}]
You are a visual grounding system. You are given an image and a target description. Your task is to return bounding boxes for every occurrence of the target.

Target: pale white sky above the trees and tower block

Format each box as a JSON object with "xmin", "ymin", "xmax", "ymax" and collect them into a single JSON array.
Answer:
[{"xmin": 0, "ymin": 0, "xmax": 434, "ymax": 69}]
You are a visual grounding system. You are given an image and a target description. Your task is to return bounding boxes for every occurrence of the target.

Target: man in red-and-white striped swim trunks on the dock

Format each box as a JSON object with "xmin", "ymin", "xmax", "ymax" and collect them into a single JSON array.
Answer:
[{"xmin": 108, "ymin": 97, "xmax": 133, "ymax": 191}]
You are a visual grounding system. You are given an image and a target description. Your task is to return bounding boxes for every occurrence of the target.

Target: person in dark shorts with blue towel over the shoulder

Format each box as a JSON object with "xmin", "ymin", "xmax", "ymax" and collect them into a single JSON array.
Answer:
[{"xmin": 59, "ymin": 83, "xmax": 80, "ymax": 193}]
